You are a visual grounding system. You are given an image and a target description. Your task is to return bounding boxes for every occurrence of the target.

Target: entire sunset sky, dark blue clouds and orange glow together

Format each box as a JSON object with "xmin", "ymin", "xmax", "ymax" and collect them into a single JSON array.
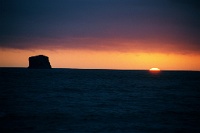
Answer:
[{"xmin": 0, "ymin": 0, "xmax": 200, "ymax": 70}]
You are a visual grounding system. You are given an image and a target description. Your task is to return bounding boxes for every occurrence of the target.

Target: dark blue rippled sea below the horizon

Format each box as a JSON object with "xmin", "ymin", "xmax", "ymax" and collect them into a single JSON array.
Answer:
[{"xmin": 0, "ymin": 68, "xmax": 200, "ymax": 133}]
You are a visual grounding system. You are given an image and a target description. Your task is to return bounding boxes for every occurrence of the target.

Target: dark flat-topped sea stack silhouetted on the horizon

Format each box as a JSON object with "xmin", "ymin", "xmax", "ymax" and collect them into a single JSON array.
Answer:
[{"xmin": 28, "ymin": 55, "xmax": 51, "ymax": 69}]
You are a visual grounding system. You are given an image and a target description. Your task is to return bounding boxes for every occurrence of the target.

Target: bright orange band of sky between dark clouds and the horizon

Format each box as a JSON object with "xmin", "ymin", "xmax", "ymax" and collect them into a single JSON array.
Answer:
[{"xmin": 0, "ymin": 49, "xmax": 200, "ymax": 70}]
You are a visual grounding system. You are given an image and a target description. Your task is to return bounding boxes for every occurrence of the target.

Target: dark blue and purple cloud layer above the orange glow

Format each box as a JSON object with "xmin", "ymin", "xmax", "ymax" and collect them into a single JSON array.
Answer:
[{"xmin": 0, "ymin": 0, "xmax": 200, "ymax": 52}]
